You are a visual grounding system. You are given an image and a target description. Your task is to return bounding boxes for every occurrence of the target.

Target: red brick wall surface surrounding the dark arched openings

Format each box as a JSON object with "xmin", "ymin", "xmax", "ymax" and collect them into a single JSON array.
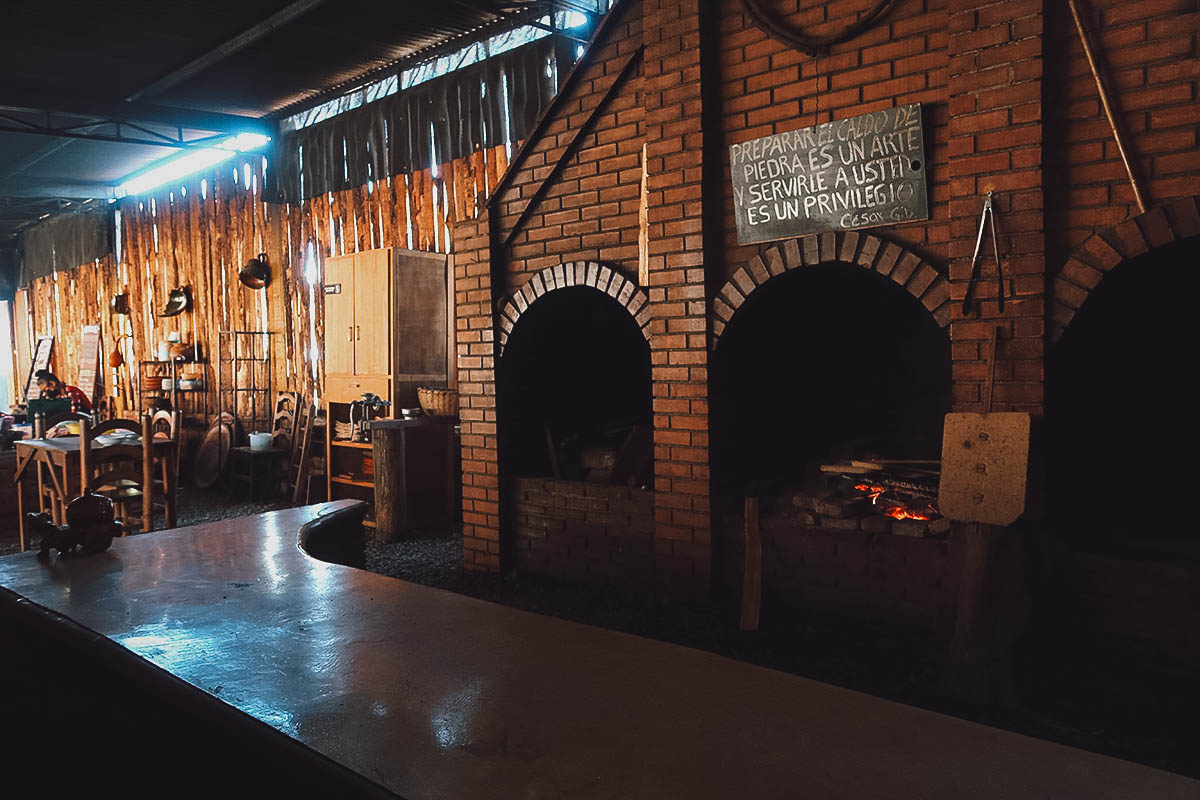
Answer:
[{"xmin": 455, "ymin": 0, "xmax": 1200, "ymax": 633}]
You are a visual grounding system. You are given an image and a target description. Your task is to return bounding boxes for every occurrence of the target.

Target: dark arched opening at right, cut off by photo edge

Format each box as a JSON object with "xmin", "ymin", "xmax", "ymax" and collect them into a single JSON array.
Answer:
[{"xmin": 1046, "ymin": 239, "xmax": 1200, "ymax": 547}]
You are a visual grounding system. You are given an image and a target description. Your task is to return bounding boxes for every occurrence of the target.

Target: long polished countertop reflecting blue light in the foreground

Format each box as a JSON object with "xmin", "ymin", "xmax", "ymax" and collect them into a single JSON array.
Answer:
[{"xmin": 0, "ymin": 501, "xmax": 1200, "ymax": 800}]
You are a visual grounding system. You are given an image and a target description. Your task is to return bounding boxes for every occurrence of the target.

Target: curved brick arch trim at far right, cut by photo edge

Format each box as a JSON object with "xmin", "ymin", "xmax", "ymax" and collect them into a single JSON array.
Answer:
[{"xmin": 1049, "ymin": 196, "xmax": 1200, "ymax": 343}]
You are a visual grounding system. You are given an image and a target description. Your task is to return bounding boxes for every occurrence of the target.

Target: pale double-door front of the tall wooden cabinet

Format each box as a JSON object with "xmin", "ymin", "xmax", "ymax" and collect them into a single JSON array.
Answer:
[{"xmin": 325, "ymin": 248, "xmax": 392, "ymax": 403}]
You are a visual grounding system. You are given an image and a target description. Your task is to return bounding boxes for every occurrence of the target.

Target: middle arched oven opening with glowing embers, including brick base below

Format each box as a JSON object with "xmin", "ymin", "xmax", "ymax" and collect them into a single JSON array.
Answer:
[{"xmin": 710, "ymin": 263, "xmax": 955, "ymax": 618}]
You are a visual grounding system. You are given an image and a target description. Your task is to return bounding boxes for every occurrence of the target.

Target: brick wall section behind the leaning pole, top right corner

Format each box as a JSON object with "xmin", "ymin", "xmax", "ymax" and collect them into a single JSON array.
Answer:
[{"xmin": 1045, "ymin": 0, "xmax": 1200, "ymax": 260}]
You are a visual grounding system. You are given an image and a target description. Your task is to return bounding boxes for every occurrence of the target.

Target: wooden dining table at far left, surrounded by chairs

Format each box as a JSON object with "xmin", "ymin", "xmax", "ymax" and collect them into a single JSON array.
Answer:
[{"xmin": 13, "ymin": 435, "xmax": 179, "ymax": 549}]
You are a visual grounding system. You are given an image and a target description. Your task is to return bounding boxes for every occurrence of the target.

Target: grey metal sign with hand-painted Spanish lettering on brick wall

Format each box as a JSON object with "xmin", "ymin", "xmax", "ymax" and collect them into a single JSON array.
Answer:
[{"xmin": 730, "ymin": 103, "xmax": 929, "ymax": 245}]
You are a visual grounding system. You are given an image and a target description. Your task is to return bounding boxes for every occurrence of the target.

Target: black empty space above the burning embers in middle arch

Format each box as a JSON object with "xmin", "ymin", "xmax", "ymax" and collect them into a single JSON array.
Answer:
[{"xmin": 710, "ymin": 263, "xmax": 950, "ymax": 493}]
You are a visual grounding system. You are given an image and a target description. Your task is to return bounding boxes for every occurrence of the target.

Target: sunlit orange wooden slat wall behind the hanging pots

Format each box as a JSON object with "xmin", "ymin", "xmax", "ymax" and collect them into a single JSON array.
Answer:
[{"xmin": 14, "ymin": 146, "xmax": 508, "ymax": 424}]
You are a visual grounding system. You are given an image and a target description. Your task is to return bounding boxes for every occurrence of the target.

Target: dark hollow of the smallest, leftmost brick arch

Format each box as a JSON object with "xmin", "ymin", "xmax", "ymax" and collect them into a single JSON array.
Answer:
[{"xmin": 497, "ymin": 287, "xmax": 652, "ymax": 480}]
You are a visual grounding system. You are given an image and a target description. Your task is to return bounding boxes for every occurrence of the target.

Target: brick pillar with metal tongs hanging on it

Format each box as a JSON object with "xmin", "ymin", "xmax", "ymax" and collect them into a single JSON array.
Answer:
[{"xmin": 947, "ymin": 0, "xmax": 1045, "ymax": 414}]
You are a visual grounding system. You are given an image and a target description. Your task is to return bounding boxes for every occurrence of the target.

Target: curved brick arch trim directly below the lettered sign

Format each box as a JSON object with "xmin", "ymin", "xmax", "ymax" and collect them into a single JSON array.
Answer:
[{"xmin": 712, "ymin": 230, "xmax": 950, "ymax": 349}]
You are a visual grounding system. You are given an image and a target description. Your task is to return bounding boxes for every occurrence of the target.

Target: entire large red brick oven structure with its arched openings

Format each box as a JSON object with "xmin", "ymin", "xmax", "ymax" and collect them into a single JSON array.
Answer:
[{"xmin": 454, "ymin": 0, "xmax": 1200, "ymax": 652}]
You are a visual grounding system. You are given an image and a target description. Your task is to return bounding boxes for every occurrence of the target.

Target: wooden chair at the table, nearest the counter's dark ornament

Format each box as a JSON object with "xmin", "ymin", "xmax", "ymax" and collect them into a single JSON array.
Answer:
[{"xmin": 79, "ymin": 416, "xmax": 154, "ymax": 533}]
